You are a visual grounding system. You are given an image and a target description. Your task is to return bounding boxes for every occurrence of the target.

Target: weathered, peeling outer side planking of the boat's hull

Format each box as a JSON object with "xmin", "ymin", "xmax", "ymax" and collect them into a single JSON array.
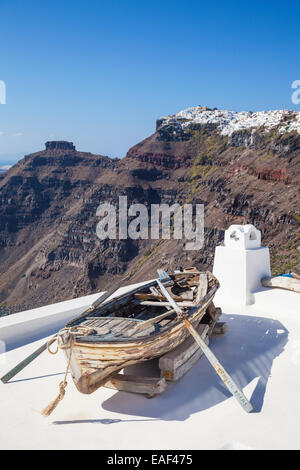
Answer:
[{"xmin": 65, "ymin": 289, "xmax": 216, "ymax": 394}]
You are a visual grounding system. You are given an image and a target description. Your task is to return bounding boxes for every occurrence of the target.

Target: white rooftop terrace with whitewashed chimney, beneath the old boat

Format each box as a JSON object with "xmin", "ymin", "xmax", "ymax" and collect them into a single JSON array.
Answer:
[{"xmin": 0, "ymin": 226, "xmax": 300, "ymax": 449}]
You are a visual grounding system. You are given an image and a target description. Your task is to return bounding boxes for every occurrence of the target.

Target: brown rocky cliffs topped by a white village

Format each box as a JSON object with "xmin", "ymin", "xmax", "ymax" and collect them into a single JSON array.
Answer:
[{"xmin": 0, "ymin": 106, "xmax": 300, "ymax": 314}]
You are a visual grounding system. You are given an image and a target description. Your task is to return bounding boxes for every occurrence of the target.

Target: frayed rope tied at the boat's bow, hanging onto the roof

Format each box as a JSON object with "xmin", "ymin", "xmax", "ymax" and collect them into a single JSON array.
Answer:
[{"xmin": 41, "ymin": 326, "xmax": 93, "ymax": 416}]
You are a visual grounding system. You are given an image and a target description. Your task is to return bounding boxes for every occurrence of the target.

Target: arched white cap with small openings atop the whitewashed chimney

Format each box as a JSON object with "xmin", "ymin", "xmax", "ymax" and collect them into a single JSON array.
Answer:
[{"xmin": 224, "ymin": 224, "xmax": 261, "ymax": 250}]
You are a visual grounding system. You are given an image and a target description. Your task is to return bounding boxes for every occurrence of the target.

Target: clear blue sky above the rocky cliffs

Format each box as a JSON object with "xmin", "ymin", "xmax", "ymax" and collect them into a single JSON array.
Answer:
[{"xmin": 0, "ymin": 0, "xmax": 300, "ymax": 164}]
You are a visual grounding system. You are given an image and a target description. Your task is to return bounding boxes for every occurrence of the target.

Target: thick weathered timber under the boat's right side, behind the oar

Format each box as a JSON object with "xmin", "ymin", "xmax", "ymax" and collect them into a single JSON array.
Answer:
[{"xmin": 158, "ymin": 323, "xmax": 209, "ymax": 372}]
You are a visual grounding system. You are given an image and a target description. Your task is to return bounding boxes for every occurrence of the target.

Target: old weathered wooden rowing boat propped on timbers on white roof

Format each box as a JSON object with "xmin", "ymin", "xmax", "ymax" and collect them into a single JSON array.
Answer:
[{"xmin": 57, "ymin": 268, "xmax": 219, "ymax": 394}]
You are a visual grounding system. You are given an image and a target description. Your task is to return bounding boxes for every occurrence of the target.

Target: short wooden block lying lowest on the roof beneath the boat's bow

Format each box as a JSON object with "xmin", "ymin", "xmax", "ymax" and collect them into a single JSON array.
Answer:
[{"xmin": 104, "ymin": 374, "xmax": 167, "ymax": 396}]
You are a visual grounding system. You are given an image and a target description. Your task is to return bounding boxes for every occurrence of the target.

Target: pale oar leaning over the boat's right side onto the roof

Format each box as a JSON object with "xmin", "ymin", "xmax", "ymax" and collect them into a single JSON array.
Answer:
[{"xmin": 157, "ymin": 279, "xmax": 253, "ymax": 413}]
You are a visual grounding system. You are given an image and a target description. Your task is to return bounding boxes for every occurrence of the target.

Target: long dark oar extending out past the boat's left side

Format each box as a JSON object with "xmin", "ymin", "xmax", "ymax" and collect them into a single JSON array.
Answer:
[{"xmin": 1, "ymin": 275, "xmax": 134, "ymax": 384}]
